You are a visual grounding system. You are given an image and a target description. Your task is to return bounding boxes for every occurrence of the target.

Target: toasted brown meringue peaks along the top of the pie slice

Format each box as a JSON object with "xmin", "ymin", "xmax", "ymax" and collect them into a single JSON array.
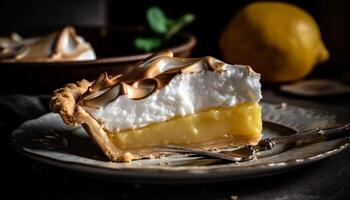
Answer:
[{"xmin": 79, "ymin": 51, "xmax": 225, "ymax": 108}]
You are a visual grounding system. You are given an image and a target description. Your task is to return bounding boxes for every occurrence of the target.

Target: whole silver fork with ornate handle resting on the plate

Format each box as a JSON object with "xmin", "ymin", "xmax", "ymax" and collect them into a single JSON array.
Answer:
[{"xmin": 155, "ymin": 123, "xmax": 350, "ymax": 162}]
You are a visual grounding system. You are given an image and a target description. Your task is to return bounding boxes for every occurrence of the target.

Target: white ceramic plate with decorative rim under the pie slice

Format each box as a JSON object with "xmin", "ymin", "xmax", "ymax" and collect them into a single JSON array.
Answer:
[{"xmin": 12, "ymin": 103, "xmax": 350, "ymax": 183}]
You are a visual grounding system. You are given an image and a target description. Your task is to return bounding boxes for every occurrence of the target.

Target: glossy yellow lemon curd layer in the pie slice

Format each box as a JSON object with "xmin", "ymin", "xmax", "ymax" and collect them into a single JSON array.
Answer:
[{"xmin": 108, "ymin": 103, "xmax": 262, "ymax": 150}]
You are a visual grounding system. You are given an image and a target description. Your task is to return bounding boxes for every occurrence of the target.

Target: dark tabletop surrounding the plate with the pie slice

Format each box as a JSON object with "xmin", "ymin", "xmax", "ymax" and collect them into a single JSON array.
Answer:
[{"xmin": 0, "ymin": 88, "xmax": 350, "ymax": 200}]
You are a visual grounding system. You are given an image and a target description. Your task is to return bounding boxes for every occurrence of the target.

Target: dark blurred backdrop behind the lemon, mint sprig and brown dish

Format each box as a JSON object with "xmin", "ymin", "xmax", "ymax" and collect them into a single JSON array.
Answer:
[{"xmin": 0, "ymin": 0, "xmax": 350, "ymax": 67}]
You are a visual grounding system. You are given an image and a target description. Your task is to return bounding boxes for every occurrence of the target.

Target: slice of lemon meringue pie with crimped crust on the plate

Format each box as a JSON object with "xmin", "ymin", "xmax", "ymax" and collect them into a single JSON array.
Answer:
[{"xmin": 51, "ymin": 51, "xmax": 262, "ymax": 161}]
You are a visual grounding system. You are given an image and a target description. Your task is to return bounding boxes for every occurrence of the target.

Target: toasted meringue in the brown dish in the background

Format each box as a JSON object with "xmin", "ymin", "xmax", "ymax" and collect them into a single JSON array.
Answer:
[{"xmin": 0, "ymin": 27, "xmax": 96, "ymax": 62}]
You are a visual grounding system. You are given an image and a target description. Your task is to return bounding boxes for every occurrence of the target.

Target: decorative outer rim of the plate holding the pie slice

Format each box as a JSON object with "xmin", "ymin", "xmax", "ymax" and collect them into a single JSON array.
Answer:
[{"xmin": 10, "ymin": 103, "xmax": 350, "ymax": 182}]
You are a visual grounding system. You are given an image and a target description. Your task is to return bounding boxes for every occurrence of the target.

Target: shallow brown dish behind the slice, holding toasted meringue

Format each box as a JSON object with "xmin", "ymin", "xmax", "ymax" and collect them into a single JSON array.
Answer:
[{"xmin": 0, "ymin": 28, "xmax": 196, "ymax": 94}]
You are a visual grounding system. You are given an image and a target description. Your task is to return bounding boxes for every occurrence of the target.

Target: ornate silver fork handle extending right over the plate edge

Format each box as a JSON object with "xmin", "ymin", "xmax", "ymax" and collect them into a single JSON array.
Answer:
[{"xmin": 257, "ymin": 123, "xmax": 350, "ymax": 150}]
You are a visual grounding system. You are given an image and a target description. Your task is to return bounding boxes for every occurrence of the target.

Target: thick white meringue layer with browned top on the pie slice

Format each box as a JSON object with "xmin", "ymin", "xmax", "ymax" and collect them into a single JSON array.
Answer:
[{"xmin": 82, "ymin": 51, "xmax": 262, "ymax": 130}]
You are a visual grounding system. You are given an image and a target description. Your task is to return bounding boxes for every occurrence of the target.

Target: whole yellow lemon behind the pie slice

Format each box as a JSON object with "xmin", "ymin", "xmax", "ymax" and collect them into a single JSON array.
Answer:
[{"xmin": 220, "ymin": 2, "xmax": 329, "ymax": 82}]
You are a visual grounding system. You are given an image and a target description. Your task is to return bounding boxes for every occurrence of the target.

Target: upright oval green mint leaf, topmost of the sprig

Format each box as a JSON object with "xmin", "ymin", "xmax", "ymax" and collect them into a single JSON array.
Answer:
[{"xmin": 146, "ymin": 6, "xmax": 169, "ymax": 34}]
